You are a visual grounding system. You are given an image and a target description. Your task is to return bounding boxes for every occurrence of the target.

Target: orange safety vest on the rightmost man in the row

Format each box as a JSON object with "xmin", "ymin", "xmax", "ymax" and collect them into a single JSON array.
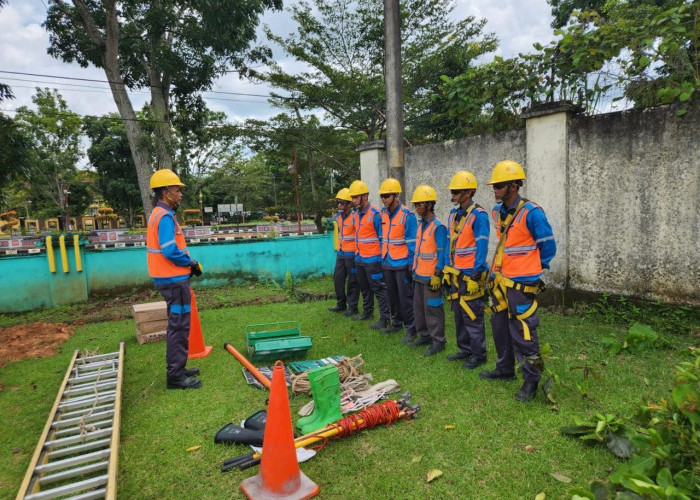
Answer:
[{"xmin": 492, "ymin": 202, "xmax": 542, "ymax": 279}]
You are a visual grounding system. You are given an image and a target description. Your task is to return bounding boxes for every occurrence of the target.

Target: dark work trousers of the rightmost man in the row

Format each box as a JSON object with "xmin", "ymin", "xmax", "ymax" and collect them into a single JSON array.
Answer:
[{"xmin": 491, "ymin": 288, "xmax": 541, "ymax": 382}]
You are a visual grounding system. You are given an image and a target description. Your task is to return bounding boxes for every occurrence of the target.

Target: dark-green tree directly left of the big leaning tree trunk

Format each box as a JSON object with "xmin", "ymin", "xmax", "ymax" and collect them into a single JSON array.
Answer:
[{"xmin": 83, "ymin": 113, "xmax": 141, "ymax": 227}]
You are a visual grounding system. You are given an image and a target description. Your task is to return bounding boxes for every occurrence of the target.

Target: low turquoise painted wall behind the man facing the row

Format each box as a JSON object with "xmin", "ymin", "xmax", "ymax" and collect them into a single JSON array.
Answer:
[{"xmin": 0, "ymin": 234, "xmax": 335, "ymax": 312}]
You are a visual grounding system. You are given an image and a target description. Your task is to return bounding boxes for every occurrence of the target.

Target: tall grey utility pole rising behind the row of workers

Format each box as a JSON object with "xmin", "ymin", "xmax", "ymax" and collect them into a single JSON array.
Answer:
[{"xmin": 384, "ymin": 0, "xmax": 405, "ymax": 189}]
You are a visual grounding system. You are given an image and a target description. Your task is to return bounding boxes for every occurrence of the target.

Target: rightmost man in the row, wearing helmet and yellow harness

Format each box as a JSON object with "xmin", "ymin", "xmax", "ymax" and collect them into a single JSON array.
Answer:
[{"xmin": 479, "ymin": 160, "xmax": 557, "ymax": 402}]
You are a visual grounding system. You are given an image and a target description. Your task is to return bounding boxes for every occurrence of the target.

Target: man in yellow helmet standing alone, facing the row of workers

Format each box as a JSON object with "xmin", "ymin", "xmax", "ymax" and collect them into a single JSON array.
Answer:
[{"xmin": 146, "ymin": 169, "xmax": 202, "ymax": 389}]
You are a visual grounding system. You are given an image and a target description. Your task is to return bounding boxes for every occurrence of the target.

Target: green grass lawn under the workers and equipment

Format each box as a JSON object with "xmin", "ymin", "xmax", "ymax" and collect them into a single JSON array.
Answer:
[{"xmin": 0, "ymin": 278, "xmax": 693, "ymax": 499}]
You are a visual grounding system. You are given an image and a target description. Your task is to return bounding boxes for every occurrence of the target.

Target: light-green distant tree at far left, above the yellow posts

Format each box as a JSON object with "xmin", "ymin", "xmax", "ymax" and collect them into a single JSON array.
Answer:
[{"xmin": 15, "ymin": 89, "xmax": 89, "ymax": 225}]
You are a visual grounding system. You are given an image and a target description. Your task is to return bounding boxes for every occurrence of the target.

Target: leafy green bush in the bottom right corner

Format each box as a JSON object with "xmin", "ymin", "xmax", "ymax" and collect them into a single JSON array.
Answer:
[{"xmin": 561, "ymin": 354, "xmax": 700, "ymax": 500}]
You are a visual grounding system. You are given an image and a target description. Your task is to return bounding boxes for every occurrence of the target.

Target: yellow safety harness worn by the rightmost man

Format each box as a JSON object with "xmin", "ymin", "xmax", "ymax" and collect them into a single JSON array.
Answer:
[{"xmin": 487, "ymin": 198, "xmax": 544, "ymax": 340}]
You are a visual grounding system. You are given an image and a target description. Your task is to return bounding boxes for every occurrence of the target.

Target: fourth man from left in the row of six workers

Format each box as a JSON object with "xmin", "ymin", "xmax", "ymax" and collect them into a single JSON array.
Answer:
[{"xmin": 410, "ymin": 185, "xmax": 448, "ymax": 356}]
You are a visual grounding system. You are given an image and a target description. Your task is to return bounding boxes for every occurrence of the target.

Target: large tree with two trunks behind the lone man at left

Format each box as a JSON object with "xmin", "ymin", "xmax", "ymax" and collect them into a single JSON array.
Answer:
[{"xmin": 44, "ymin": 0, "xmax": 282, "ymax": 214}]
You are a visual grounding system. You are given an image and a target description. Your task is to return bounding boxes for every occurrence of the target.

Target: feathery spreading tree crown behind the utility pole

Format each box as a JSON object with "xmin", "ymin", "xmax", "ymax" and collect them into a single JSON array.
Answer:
[{"xmin": 253, "ymin": 0, "xmax": 497, "ymax": 140}]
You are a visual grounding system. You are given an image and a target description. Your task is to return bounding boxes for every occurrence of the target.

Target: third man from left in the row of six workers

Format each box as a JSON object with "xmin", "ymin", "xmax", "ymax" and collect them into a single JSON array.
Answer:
[{"xmin": 379, "ymin": 177, "xmax": 416, "ymax": 336}]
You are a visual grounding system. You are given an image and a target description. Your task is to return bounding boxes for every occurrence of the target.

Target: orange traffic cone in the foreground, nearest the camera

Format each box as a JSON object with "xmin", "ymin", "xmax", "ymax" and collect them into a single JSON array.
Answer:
[{"xmin": 241, "ymin": 361, "xmax": 319, "ymax": 500}]
